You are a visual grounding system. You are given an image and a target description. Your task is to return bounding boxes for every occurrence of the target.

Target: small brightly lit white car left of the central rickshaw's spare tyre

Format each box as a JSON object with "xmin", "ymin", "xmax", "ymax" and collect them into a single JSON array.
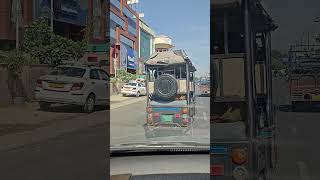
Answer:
[{"xmin": 121, "ymin": 82, "xmax": 147, "ymax": 97}]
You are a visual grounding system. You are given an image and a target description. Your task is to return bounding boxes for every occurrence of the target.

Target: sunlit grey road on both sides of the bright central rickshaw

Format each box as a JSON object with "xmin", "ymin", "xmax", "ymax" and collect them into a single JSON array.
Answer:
[{"xmin": 110, "ymin": 88, "xmax": 210, "ymax": 145}]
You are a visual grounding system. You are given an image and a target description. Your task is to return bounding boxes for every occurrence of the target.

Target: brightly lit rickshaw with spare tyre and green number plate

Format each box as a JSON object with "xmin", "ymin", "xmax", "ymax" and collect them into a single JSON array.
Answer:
[{"xmin": 144, "ymin": 50, "xmax": 195, "ymax": 137}]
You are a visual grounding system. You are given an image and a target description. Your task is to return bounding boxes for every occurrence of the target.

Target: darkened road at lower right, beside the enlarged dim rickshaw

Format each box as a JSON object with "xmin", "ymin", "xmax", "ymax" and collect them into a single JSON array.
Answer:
[{"xmin": 273, "ymin": 78, "xmax": 320, "ymax": 180}]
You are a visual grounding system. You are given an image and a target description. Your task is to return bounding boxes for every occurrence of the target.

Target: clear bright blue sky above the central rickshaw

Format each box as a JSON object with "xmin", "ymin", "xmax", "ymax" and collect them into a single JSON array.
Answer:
[{"xmin": 132, "ymin": 0, "xmax": 210, "ymax": 76}]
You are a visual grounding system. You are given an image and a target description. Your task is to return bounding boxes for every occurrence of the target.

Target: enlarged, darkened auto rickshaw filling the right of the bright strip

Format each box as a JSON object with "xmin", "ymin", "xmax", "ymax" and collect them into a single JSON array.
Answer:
[{"xmin": 210, "ymin": 0, "xmax": 277, "ymax": 180}]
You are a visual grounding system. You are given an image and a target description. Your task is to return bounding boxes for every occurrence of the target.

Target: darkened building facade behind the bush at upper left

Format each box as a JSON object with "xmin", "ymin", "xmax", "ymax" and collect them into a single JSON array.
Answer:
[{"xmin": 0, "ymin": 0, "xmax": 110, "ymax": 70}]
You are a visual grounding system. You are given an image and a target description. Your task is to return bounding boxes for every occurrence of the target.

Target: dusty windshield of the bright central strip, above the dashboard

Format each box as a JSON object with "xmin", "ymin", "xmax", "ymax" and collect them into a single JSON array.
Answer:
[{"xmin": 110, "ymin": 1, "xmax": 210, "ymax": 150}]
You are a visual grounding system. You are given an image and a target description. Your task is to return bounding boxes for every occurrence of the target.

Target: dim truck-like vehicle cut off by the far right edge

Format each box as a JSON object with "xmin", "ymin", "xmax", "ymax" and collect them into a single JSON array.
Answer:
[{"xmin": 289, "ymin": 45, "xmax": 320, "ymax": 110}]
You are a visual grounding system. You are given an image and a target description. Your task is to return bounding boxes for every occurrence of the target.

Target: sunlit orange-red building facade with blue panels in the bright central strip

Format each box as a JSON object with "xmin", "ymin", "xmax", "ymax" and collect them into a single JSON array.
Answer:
[{"xmin": 110, "ymin": 0, "xmax": 139, "ymax": 75}]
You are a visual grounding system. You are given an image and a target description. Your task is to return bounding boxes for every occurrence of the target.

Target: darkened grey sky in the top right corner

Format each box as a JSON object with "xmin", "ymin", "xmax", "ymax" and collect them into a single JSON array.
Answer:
[{"xmin": 263, "ymin": 0, "xmax": 320, "ymax": 52}]
